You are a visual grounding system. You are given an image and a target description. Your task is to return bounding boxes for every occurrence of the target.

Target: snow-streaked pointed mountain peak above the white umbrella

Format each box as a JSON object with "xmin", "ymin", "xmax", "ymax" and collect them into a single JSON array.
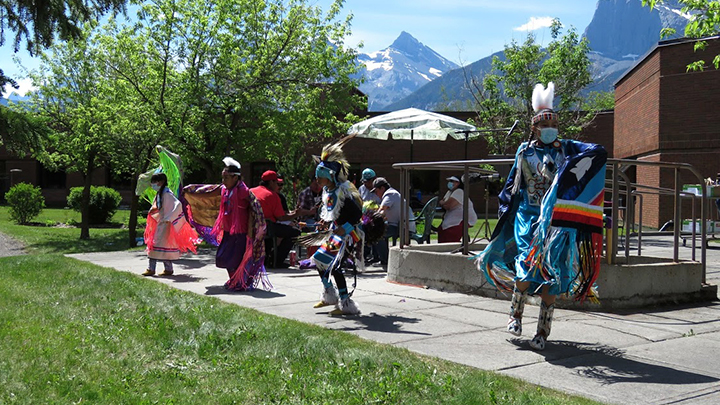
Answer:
[{"xmin": 358, "ymin": 31, "xmax": 458, "ymax": 111}]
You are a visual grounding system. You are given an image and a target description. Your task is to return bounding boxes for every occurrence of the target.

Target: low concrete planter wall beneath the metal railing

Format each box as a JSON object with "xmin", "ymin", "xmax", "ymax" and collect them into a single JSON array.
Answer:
[{"xmin": 388, "ymin": 243, "xmax": 717, "ymax": 310}]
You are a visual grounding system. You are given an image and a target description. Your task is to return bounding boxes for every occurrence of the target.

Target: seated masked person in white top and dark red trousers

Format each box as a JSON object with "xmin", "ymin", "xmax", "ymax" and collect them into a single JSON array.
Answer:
[{"xmin": 438, "ymin": 176, "xmax": 477, "ymax": 243}]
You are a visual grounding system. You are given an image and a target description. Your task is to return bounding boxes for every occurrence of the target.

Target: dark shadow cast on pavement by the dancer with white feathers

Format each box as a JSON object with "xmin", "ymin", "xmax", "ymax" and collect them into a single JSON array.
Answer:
[{"xmin": 508, "ymin": 339, "xmax": 720, "ymax": 385}]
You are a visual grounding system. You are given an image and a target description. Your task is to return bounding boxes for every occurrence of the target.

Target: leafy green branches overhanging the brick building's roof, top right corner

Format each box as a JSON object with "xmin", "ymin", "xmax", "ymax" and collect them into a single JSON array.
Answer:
[{"xmin": 642, "ymin": 0, "xmax": 720, "ymax": 71}]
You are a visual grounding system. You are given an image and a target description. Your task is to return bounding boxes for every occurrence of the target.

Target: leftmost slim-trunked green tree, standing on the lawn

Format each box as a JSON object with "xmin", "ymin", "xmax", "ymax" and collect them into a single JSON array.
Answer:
[{"xmin": 31, "ymin": 30, "xmax": 117, "ymax": 239}]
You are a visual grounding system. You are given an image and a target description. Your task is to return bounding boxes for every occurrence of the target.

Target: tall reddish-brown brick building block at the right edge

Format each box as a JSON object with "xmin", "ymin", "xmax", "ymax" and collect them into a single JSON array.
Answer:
[{"xmin": 614, "ymin": 37, "xmax": 720, "ymax": 227}]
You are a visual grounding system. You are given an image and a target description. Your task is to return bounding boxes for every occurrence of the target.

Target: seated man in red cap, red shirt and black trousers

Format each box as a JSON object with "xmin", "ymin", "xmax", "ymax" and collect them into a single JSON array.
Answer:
[{"xmin": 250, "ymin": 170, "xmax": 300, "ymax": 268}]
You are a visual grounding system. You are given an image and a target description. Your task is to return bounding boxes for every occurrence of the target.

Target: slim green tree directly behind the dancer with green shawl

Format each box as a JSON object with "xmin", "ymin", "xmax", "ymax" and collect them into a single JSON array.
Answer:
[{"xmin": 93, "ymin": 19, "xmax": 173, "ymax": 246}]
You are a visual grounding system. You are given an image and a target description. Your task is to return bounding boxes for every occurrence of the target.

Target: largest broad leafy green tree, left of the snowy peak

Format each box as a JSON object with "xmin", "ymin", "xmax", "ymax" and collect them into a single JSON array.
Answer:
[{"xmin": 98, "ymin": 0, "xmax": 364, "ymax": 179}]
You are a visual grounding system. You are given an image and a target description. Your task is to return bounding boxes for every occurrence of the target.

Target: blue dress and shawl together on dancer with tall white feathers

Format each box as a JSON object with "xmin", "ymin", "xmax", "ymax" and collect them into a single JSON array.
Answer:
[{"xmin": 476, "ymin": 140, "xmax": 607, "ymax": 301}]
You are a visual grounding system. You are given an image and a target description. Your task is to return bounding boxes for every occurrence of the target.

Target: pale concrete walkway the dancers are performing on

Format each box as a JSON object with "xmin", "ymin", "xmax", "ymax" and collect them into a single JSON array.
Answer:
[{"xmin": 68, "ymin": 241, "xmax": 720, "ymax": 404}]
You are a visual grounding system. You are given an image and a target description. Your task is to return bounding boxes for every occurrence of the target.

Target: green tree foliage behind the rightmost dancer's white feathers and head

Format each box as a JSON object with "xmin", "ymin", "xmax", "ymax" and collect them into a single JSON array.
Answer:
[{"xmin": 466, "ymin": 19, "xmax": 592, "ymax": 154}]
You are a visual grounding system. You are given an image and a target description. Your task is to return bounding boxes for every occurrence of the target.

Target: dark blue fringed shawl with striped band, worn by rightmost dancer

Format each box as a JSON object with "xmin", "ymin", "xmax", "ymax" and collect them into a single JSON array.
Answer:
[{"xmin": 475, "ymin": 141, "xmax": 607, "ymax": 301}]
